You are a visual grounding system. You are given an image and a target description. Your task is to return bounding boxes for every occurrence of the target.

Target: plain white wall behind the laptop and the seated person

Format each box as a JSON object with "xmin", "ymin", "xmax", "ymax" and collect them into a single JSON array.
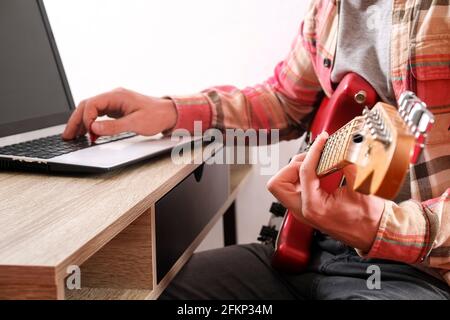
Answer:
[{"xmin": 45, "ymin": 0, "xmax": 308, "ymax": 248}]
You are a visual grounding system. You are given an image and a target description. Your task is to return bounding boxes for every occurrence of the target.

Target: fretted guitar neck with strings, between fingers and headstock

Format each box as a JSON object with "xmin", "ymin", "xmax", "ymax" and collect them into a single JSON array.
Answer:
[{"xmin": 317, "ymin": 117, "xmax": 362, "ymax": 177}]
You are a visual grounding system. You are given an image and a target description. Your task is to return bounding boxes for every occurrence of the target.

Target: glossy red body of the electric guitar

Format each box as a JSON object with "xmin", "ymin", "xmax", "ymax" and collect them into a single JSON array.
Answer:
[{"xmin": 272, "ymin": 73, "xmax": 378, "ymax": 273}]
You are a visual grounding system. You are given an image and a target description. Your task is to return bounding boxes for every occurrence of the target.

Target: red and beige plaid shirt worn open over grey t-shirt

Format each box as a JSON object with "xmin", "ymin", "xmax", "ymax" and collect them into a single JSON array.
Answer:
[{"xmin": 172, "ymin": 0, "xmax": 450, "ymax": 284}]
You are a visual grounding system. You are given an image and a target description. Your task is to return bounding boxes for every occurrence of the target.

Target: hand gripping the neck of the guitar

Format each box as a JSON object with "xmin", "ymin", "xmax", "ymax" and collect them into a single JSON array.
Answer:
[{"xmin": 267, "ymin": 133, "xmax": 385, "ymax": 252}]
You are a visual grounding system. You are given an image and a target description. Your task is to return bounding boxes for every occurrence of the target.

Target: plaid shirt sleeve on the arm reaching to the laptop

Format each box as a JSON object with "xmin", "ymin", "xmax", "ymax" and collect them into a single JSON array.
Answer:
[{"xmin": 165, "ymin": 21, "xmax": 322, "ymax": 139}]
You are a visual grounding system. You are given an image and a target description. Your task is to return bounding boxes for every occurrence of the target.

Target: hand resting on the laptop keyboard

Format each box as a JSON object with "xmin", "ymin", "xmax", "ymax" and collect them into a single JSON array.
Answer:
[{"xmin": 63, "ymin": 89, "xmax": 177, "ymax": 140}]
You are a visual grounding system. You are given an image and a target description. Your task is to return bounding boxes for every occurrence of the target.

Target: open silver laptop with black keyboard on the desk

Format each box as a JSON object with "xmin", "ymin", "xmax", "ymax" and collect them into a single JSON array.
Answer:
[{"xmin": 0, "ymin": 0, "xmax": 186, "ymax": 173}]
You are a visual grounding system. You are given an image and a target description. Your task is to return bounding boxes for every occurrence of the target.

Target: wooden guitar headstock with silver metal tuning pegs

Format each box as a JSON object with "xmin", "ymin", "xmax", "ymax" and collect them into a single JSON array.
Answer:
[{"xmin": 350, "ymin": 92, "xmax": 434, "ymax": 199}]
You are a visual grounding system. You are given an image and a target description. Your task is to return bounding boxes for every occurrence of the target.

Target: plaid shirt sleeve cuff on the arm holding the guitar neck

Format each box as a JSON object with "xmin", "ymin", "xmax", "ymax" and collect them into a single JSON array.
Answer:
[{"xmin": 358, "ymin": 189, "xmax": 450, "ymax": 270}]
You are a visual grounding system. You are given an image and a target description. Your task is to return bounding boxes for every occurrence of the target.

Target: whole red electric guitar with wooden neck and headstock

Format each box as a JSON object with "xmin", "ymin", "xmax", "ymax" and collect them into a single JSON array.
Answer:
[{"xmin": 272, "ymin": 74, "xmax": 434, "ymax": 272}]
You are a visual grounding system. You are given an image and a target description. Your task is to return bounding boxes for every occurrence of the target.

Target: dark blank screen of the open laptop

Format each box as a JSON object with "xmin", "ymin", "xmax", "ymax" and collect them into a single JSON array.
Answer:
[{"xmin": 0, "ymin": 0, "xmax": 73, "ymax": 137}]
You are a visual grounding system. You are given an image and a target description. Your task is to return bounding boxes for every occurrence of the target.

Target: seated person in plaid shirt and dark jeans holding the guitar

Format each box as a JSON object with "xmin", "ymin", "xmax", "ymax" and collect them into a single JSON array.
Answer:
[{"xmin": 64, "ymin": 0, "xmax": 450, "ymax": 299}]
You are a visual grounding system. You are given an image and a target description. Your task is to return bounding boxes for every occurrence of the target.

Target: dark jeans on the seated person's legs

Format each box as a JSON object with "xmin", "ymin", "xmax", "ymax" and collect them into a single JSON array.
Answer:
[{"xmin": 161, "ymin": 234, "xmax": 450, "ymax": 300}]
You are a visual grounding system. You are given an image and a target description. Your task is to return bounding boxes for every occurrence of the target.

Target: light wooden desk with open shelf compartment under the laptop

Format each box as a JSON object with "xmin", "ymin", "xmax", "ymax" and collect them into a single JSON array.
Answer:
[{"xmin": 0, "ymin": 146, "xmax": 251, "ymax": 299}]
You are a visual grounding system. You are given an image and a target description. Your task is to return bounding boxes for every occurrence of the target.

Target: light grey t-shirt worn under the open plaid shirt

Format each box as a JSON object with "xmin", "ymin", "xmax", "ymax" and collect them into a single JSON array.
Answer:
[{"xmin": 331, "ymin": 0, "xmax": 397, "ymax": 105}]
